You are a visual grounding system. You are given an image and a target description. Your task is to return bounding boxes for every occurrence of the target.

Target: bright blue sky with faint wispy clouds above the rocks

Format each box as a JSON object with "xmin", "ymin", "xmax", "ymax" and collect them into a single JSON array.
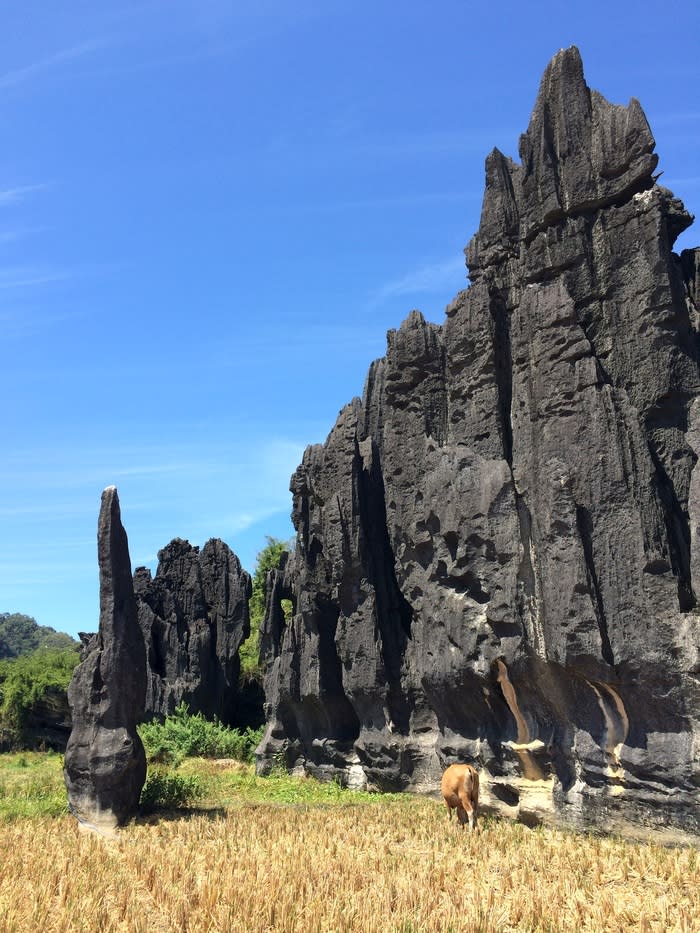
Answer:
[{"xmin": 0, "ymin": 0, "xmax": 700, "ymax": 633}]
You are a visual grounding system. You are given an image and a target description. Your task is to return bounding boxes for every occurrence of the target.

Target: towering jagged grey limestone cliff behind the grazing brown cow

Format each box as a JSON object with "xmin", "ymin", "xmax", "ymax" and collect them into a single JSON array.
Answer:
[{"xmin": 258, "ymin": 48, "xmax": 700, "ymax": 838}]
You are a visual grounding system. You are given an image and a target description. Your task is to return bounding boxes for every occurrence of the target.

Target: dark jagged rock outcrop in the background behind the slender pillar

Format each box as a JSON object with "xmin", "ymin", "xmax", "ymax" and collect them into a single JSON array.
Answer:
[{"xmin": 134, "ymin": 538, "xmax": 251, "ymax": 724}]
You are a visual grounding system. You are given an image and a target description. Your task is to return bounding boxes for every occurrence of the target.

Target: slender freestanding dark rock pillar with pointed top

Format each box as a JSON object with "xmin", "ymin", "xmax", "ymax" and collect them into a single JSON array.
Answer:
[{"xmin": 64, "ymin": 486, "xmax": 146, "ymax": 830}]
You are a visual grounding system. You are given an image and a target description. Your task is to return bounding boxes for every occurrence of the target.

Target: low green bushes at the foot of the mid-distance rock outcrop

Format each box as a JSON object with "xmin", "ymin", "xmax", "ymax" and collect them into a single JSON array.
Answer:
[{"xmin": 138, "ymin": 703, "xmax": 262, "ymax": 767}]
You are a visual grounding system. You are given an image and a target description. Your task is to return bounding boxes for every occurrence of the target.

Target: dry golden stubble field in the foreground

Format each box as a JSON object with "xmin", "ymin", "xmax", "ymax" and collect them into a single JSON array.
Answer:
[{"xmin": 0, "ymin": 762, "xmax": 700, "ymax": 933}]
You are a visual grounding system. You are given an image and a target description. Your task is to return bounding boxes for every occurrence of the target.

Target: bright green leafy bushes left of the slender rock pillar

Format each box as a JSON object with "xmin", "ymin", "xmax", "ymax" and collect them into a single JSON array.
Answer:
[{"xmin": 0, "ymin": 648, "xmax": 80, "ymax": 748}]
